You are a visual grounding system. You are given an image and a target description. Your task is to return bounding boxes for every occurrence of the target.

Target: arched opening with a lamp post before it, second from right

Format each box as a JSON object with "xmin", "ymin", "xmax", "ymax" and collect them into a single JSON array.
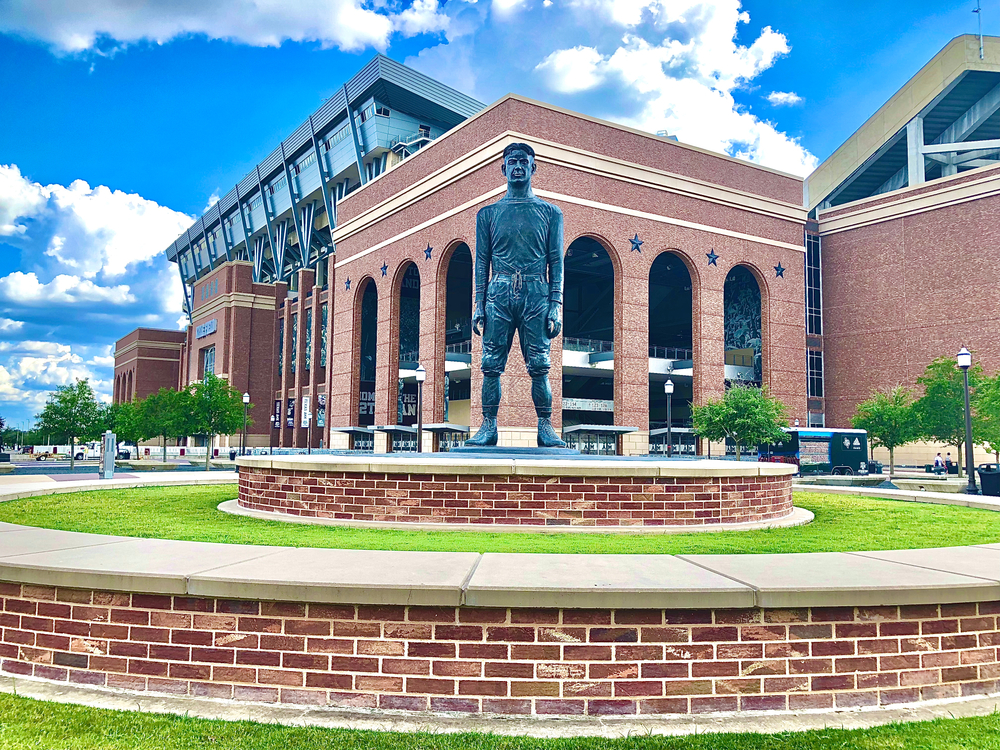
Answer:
[{"xmin": 649, "ymin": 252, "xmax": 695, "ymax": 455}]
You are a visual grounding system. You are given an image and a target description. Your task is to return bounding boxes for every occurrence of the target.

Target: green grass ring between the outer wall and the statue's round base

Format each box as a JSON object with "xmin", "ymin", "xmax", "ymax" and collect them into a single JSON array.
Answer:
[{"xmin": 0, "ymin": 486, "xmax": 1000, "ymax": 554}]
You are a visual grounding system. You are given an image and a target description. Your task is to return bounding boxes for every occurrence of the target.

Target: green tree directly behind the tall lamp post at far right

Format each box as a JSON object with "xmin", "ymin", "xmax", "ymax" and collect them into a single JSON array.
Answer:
[{"xmin": 913, "ymin": 357, "xmax": 983, "ymax": 476}]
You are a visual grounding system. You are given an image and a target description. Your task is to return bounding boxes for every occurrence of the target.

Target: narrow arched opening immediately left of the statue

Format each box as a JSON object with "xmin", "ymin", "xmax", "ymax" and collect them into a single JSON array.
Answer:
[{"xmin": 438, "ymin": 242, "xmax": 472, "ymax": 450}]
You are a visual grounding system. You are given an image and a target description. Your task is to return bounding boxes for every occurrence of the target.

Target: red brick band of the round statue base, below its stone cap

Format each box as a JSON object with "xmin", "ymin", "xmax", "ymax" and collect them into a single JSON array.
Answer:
[{"xmin": 239, "ymin": 467, "xmax": 792, "ymax": 527}]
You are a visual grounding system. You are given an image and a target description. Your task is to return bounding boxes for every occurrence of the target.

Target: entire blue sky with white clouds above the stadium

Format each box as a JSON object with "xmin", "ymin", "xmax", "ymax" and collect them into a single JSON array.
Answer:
[{"xmin": 0, "ymin": 0, "xmax": 988, "ymax": 423}]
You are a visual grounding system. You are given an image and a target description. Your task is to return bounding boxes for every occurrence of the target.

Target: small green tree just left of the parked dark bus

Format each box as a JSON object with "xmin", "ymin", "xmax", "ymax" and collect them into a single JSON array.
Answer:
[{"xmin": 691, "ymin": 384, "xmax": 788, "ymax": 461}]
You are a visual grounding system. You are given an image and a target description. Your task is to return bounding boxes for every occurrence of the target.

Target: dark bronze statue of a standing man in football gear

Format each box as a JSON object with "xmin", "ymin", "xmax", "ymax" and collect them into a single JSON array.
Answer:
[{"xmin": 465, "ymin": 143, "xmax": 566, "ymax": 448}]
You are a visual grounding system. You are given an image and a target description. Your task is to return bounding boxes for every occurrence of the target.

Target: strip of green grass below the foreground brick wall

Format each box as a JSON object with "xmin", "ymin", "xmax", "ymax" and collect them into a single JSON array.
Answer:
[{"xmin": 0, "ymin": 695, "xmax": 1000, "ymax": 750}]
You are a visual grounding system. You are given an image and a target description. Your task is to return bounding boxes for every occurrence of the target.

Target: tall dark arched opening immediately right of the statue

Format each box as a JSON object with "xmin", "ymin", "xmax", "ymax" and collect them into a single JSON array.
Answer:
[{"xmin": 562, "ymin": 237, "xmax": 615, "ymax": 453}]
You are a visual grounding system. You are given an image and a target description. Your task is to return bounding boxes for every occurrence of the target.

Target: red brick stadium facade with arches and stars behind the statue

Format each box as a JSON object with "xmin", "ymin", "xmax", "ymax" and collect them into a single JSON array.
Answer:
[{"xmin": 115, "ymin": 36, "xmax": 1000, "ymax": 456}]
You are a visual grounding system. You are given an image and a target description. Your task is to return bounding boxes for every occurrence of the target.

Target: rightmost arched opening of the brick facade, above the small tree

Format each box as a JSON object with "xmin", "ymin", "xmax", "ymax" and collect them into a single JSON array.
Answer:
[{"xmin": 723, "ymin": 266, "xmax": 764, "ymax": 386}]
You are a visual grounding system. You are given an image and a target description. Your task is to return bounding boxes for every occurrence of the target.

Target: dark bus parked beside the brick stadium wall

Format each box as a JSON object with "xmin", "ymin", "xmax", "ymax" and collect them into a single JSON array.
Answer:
[{"xmin": 758, "ymin": 429, "xmax": 868, "ymax": 474}]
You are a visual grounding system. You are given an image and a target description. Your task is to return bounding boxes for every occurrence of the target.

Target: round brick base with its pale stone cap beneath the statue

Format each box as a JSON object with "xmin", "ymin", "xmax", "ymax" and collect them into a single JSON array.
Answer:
[{"xmin": 239, "ymin": 457, "xmax": 794, "ymax": 526}]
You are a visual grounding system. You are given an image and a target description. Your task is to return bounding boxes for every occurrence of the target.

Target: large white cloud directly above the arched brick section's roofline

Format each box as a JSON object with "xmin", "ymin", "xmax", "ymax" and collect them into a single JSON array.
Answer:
[{"xmin": 409, "ymin": 0, "xmax": 817, "ymax": 175}]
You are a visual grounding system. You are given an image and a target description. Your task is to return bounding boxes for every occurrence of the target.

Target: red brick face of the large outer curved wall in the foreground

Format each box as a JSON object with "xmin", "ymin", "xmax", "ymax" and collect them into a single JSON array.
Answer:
[{"xmin": 0, "ymin": 583, "xmax": 1000, "ymax": 716}]
